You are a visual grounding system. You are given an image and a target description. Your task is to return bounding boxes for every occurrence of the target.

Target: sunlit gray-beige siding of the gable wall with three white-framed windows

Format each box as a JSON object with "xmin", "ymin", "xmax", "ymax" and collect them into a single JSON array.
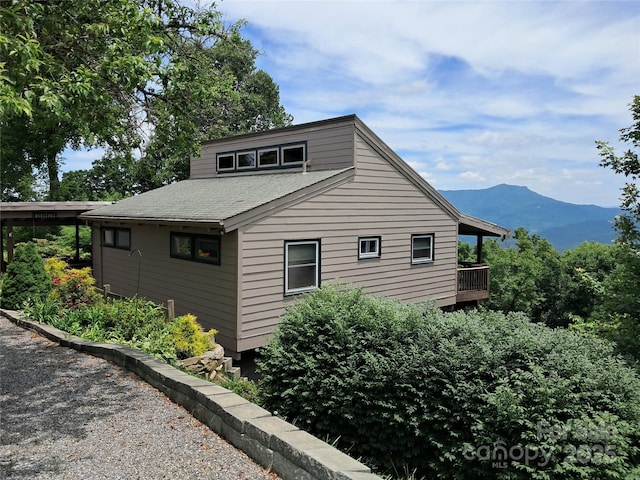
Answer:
[{"xmin": 239, "ymin": 133, "xmax": 458, "ymax": 350}]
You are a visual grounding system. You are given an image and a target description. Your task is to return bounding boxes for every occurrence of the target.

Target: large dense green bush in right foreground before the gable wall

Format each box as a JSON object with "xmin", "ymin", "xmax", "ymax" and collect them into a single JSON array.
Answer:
[{"xmin": 257, "ymin": 285, "xmax": 640, "ymax": 479}]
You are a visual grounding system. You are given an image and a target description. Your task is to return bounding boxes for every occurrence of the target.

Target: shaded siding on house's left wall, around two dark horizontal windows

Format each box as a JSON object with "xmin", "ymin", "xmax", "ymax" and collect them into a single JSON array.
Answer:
[{"xmin": 94, "ymin": 224, "xmax": 237, "ymax": 351}]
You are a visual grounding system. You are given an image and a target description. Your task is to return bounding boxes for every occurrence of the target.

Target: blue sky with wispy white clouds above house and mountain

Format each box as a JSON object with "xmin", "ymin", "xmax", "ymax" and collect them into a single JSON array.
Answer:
[{"xmin": 62, "ymin": 0, "xmax": 640, "ymax": 206}]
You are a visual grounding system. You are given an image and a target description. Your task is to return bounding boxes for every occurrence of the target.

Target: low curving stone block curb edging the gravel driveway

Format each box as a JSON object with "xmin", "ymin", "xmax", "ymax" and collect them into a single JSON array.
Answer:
[{"xmin": 0, "ymin": 310, "xmax": 382, "ymax": 480}]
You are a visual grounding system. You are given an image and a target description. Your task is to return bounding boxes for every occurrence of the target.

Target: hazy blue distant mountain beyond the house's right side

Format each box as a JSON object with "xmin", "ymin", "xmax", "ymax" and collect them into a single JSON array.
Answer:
[{"xmin": 440, "ymin": 184, "xmax": 620, "ymax": 251}]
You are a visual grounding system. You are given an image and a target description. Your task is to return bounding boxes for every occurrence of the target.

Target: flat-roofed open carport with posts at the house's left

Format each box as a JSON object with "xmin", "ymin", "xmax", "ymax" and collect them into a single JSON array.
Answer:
[{"xmin": 0, "ymin": 202, "xmax": 110, "ymax": 272}]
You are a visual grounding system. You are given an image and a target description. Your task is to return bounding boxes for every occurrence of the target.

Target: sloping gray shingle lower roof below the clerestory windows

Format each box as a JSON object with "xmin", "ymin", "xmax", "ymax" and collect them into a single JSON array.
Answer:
[{"xmin": 82, "ymin": 169, "xmax": 348, "ymax": 223}]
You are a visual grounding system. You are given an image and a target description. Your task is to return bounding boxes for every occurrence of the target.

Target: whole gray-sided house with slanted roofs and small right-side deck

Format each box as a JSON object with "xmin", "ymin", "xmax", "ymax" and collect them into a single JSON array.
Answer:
[{"xmin": 81, "ymin": 115, "xmax": 508, "ymax": 356}]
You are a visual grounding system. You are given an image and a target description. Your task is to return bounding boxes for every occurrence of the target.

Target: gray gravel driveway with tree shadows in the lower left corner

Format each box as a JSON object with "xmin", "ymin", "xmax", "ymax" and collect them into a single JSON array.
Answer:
[{"xmin": 0, "ymin": 317, "xmax": 277, "ymax": 480}]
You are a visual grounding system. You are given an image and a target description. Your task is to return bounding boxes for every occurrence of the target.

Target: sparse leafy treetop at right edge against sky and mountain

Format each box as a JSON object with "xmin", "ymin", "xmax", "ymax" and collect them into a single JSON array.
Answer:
[{"xmin": 596, "ymin": 95, "xmax": 640, "ymax": 250}]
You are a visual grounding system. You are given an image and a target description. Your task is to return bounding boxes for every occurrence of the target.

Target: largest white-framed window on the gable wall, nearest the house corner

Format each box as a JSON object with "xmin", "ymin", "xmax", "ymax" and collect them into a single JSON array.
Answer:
[{"xmin": 284, "ymin": 240, "xmax": 320, "ymax": 294}]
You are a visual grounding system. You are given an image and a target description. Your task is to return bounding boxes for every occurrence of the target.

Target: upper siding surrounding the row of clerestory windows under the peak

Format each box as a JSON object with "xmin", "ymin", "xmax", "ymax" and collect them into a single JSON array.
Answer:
[{"xmin": 191, "ymin": 120, "xmax": 355, "ymax": 178}]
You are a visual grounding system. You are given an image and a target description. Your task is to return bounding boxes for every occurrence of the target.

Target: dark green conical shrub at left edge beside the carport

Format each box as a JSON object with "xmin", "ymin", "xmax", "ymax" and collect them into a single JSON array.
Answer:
[{"xmin": 0, "ymin": 242, "xmax": 50, "ymax": 310}]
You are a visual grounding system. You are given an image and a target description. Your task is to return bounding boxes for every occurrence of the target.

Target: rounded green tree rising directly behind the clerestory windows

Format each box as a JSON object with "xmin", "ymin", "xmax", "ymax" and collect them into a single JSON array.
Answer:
[{"xmin": 135, "ymin": 25, "xmax": 291, "ymax": 191}]
